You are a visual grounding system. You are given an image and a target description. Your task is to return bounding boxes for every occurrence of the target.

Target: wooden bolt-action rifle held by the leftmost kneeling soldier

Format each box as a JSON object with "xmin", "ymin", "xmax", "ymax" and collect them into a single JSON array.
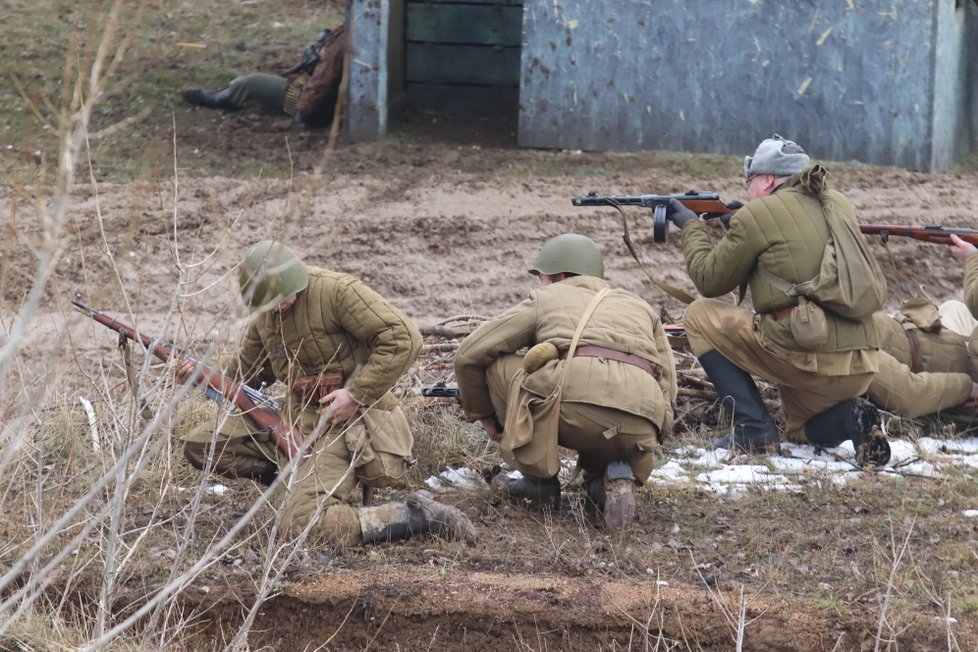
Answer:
[{"xmin": 71, "ymin": 299, "xmax": 302, "ymax": 459}]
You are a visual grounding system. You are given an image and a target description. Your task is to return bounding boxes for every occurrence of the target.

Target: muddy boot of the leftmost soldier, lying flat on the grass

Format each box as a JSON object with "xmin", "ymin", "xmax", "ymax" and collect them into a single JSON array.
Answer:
[{"xmin": 357, "ymin": 491, "xmax": 475, "ymax": 543}]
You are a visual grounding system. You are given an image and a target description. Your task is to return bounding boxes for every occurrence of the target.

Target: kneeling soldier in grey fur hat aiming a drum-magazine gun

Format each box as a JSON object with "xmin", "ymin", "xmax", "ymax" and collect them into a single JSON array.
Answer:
[{"xmin": 667, "ymin": 134, "xmax": 889, "ymax": 465}]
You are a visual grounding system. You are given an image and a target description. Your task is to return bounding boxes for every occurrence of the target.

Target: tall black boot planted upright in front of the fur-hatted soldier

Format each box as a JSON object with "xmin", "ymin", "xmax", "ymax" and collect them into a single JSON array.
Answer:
[{"xmin": 699, "ymin": 350, "xmax": 779, "ymax": 453}]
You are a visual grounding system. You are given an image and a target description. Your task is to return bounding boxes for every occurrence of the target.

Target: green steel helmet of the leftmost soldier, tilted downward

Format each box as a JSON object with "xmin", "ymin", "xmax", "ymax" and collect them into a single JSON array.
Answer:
[{"xmin": 238, "ymin": 240, "xmax": 309, "ymax": 312}]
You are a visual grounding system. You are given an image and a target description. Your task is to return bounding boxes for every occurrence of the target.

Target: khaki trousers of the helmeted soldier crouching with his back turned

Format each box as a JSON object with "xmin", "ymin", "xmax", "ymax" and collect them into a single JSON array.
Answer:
[{"xmin": 486, "ymin": 355, "xmax": 659, "ymax": 484}]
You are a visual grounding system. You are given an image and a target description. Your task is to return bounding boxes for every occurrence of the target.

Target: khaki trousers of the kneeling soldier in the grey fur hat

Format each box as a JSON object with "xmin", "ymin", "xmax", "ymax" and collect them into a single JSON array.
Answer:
[{"xmin": 683, "ymin": 299, "xmax": 874, "ymax": 443}]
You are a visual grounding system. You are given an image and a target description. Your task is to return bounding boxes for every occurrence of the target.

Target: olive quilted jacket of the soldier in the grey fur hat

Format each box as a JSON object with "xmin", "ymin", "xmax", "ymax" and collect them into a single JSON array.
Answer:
[{"xmin": 682, "ymin": 169, "xmax": 885, "ymax": 375}]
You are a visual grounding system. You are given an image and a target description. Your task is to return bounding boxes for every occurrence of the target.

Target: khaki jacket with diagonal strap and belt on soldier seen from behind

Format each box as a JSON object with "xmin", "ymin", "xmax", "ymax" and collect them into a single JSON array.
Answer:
[{"xmin": 455, "ymin": 276, "xmax": 677, "ymax": 438}]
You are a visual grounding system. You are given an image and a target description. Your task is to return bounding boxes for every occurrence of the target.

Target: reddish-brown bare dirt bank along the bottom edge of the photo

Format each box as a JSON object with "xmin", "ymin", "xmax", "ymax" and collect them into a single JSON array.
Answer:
[{"xmin": 173, "ymin": 567, "xmax": 960, "ymax": 652}]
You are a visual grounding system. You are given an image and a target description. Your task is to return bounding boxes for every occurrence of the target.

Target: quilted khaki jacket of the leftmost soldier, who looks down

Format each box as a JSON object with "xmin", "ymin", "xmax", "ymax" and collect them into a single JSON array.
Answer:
[{"xmin": 226, "ymin": 267, "xmax": 421, "ymax": 409}]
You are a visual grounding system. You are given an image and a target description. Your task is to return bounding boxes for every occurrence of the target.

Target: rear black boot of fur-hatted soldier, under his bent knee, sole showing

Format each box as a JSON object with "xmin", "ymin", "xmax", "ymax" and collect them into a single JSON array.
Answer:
[{"xmin": 805, "ymin": 398, "xmax": 890, "ymax": 466}]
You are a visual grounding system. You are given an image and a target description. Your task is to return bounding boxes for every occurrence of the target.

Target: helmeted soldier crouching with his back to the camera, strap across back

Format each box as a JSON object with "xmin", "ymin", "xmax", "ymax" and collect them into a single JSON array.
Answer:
[{"xmin": 455, "ymin": 233, "xmax": 677, "ymax": 528}]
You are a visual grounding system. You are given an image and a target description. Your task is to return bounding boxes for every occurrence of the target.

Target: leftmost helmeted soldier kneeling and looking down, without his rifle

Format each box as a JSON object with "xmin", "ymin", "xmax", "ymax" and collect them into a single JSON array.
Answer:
[{"xmin": 176, "ymin": 240, "xmax": 473, "ymax": 544}]
